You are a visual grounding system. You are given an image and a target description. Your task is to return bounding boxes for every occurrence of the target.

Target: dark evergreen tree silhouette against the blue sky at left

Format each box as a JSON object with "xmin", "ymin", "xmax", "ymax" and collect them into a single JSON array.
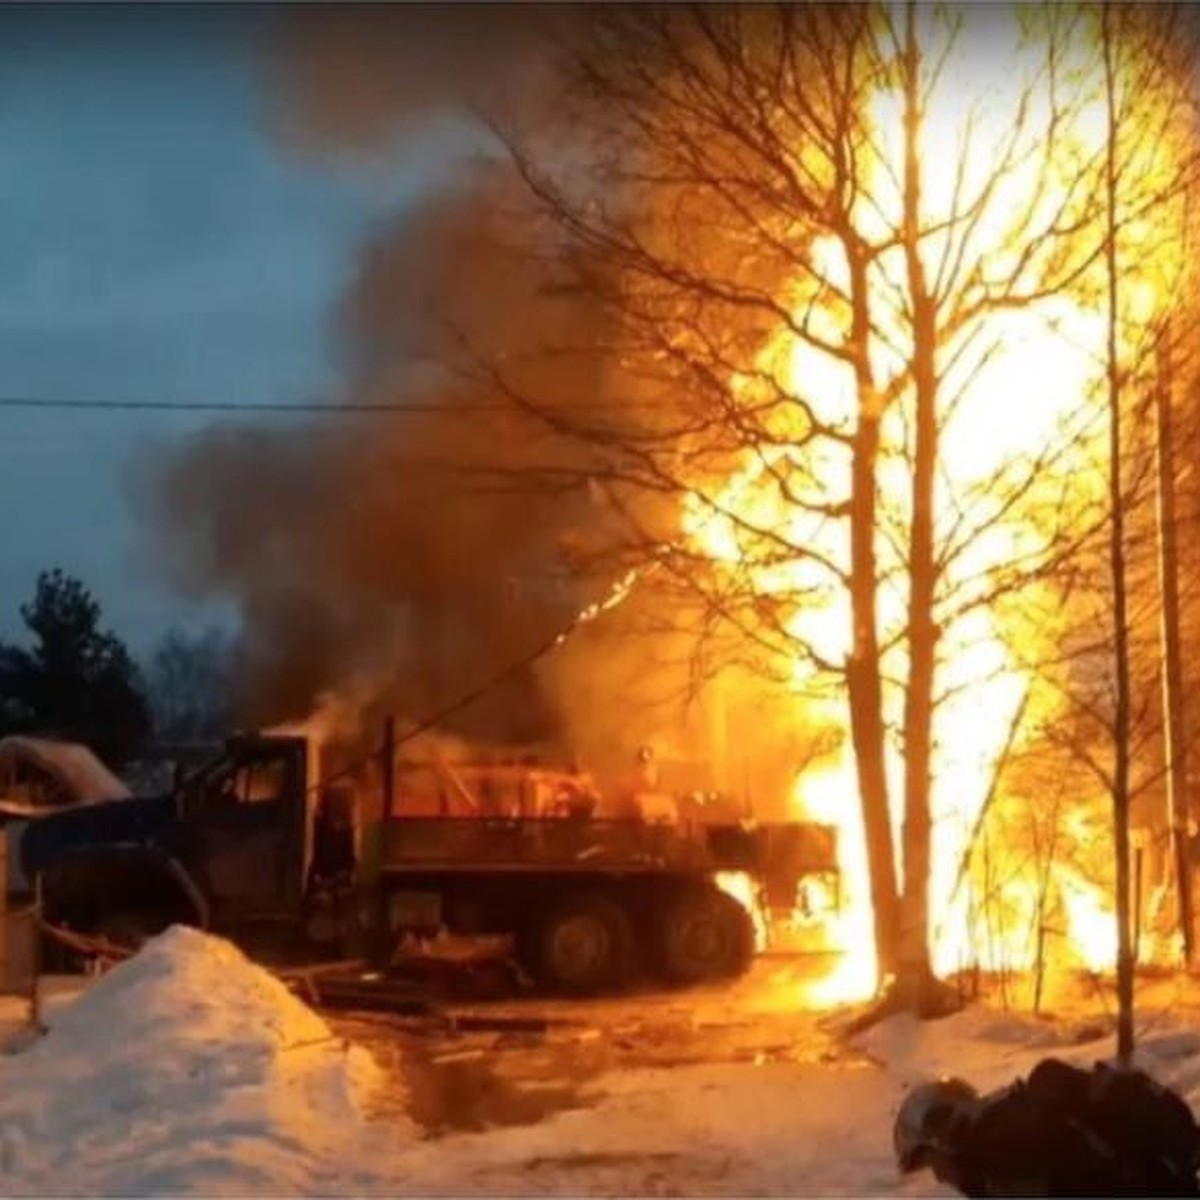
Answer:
[{"xmin": 0, "ymin": 568, "xmax": 150, "ymax": 767}]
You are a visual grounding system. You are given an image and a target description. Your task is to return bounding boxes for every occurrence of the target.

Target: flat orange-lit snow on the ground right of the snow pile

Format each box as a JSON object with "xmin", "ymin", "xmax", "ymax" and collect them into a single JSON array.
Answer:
[{"xmin": 404, "ymin": 1009, "xmax": 1200, "ymax": 1195}]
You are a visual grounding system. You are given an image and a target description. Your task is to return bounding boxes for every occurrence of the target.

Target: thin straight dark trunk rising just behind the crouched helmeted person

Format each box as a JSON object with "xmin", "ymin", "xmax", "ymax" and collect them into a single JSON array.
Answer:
[{"xmin": 1100, "ymin": 5, "xmax": 1133, "ymax": 1062}]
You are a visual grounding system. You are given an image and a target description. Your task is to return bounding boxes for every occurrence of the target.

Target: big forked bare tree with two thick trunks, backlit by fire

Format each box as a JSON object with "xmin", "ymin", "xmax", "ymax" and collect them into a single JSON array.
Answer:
[{"xmin": 472, "ymin": 5, "xmax": 1137, "ymax": 1006}]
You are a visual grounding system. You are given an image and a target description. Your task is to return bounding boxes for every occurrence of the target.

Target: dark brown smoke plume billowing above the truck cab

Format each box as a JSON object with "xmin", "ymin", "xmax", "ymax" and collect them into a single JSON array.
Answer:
[{"xmin": 140, "ymin": 148, "xmax": 604, "ymax": 739}]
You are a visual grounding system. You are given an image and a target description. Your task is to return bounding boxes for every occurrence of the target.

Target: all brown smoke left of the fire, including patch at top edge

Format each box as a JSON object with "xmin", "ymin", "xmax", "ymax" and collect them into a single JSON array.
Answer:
[{"xmin": 137, "ymin": 5, "xmax": 803, "ymax": 811}]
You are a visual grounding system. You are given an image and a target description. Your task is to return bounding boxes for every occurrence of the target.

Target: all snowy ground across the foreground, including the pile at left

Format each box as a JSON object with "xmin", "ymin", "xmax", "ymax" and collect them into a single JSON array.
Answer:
[{"xmin": 0, "ymin": 929, "xmax": 1200, "ymax": 1195}]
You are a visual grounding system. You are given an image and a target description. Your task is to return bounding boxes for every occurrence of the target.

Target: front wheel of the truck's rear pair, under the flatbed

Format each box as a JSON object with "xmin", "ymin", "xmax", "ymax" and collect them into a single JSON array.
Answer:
[{"xmin": 517, "ymin": 892, "xmax": 636, "ymax": 996}]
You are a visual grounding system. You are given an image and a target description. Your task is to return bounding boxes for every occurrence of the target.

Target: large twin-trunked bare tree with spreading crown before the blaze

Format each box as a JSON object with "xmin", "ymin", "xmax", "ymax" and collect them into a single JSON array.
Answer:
[{"xmin": 312, "ymin": 4, "xmax": 1200, "ymax": 1007}]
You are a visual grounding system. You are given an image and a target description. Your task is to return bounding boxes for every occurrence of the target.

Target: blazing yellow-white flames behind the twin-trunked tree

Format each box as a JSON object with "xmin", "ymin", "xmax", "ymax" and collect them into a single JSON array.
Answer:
[{"xmin": 684, "ymin": 8, "xmax": 1185, "ymax": 1002}]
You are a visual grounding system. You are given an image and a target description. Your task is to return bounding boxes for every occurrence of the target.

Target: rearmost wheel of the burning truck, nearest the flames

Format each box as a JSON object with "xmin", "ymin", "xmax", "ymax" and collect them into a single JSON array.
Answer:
[{"xmin": 659, "ymin": 887, "xmax": 755, "ymax": 985}]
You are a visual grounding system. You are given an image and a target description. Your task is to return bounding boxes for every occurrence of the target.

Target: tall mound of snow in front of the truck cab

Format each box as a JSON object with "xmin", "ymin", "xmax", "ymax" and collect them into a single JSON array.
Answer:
[{"xmin": 0, "ymin": 926, "xmax": 410, "ymax": 1195}]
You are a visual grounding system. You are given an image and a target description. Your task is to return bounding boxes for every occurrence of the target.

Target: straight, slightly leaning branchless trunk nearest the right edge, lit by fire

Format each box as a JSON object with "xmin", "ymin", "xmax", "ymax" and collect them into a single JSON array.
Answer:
[{"xmin": 1154, "ymin": 325, "xmax": 1195, "ymax": 967}]
